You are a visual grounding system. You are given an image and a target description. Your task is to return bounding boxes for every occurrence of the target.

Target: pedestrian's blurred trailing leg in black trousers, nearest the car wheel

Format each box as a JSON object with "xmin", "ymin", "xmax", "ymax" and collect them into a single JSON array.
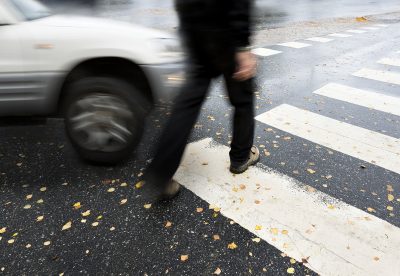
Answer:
[{"xmin": 145, "ymin": 73, "xmax": 211, "ymax": 191}]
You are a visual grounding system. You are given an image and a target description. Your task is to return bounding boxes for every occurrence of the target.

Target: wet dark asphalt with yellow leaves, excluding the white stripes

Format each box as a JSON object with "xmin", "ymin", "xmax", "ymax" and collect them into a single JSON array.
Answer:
[{"xmin": 0, "ymin": 1, "xmax": 400, "ymax": 275}]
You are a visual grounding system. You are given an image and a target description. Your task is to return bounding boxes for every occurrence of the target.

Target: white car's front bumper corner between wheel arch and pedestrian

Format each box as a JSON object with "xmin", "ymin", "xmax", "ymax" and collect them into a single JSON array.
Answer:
[{"xmin": 142, "ymin": 62, "xmax": 185, "ymax": 104}]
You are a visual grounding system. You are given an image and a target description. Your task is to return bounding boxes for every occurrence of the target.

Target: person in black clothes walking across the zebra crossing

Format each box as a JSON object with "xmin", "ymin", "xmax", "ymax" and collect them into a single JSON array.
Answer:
[{"xmin": 145, "ymin": 0, "xmax": 260, "ymax": 198}]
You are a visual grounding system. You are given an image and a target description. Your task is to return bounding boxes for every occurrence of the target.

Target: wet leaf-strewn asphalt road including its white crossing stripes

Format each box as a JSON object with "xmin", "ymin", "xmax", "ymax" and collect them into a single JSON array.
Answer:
[{"xmin": 0, "ymin": 1, "xmax": 400, "ymax": 275}]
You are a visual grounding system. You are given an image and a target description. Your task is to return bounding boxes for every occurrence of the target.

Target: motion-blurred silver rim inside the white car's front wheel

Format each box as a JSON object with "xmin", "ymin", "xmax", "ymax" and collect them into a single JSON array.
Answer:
[{"xmin": 67, "ymin": 93, "xmax": 135, "ymax": 152}]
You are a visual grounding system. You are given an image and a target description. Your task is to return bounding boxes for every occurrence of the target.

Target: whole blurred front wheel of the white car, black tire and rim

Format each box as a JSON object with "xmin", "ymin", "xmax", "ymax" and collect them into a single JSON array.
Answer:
[{"xmin": 63, "ymin": 77, "xmax": 149, "ymax": 164}]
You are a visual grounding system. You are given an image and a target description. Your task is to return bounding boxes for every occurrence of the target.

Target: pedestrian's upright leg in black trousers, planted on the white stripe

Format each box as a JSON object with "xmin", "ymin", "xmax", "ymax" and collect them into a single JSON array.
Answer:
[{"xmin": 224, "ymin": 73, "xmax": 254, "ymax": 164}]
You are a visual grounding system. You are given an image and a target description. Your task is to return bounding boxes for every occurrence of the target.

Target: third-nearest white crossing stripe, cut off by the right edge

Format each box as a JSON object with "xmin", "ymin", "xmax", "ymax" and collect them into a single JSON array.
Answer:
[{"xmin": 314, "ymin": 83, "xmax": 400, "ymax": 116}]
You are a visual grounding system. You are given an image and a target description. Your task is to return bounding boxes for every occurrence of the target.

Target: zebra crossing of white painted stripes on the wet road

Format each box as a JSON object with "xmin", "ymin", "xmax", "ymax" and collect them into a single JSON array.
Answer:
[{"xmin": 176, "ymin": 33, "xmax": 400, "ymax": 275}]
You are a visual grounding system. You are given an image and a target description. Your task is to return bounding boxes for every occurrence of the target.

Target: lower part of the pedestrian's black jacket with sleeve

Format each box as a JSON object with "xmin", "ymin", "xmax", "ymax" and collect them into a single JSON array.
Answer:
[{"xmin": 175, "ymin": 0, "xmax": 252, "ymax": 48}]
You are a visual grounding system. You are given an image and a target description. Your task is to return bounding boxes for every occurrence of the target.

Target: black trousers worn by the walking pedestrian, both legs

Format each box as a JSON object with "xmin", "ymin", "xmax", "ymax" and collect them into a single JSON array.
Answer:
[{"xmin": 146, "ymin": 32, "xmax": 254, "ymax": 190}]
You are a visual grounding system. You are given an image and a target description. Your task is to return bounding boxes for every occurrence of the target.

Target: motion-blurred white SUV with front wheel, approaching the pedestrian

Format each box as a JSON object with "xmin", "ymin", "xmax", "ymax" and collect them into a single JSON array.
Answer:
[{"xmin": 0, "ymin": 0, "xmax": 184, "ymax": 163}]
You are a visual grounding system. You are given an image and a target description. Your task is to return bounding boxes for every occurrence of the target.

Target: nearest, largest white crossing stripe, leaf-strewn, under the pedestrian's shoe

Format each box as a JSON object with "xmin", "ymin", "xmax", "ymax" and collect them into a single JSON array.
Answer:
[{"xmin": 175, "ymin": 139, "xmax": 400, "ymax": 275}]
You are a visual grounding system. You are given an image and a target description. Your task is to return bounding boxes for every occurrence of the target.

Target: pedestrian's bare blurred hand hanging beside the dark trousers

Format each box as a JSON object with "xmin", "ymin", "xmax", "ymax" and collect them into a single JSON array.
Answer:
[{"xmin": 233, "ymin": 51, "xmax": 257, "ymax": 81}]
